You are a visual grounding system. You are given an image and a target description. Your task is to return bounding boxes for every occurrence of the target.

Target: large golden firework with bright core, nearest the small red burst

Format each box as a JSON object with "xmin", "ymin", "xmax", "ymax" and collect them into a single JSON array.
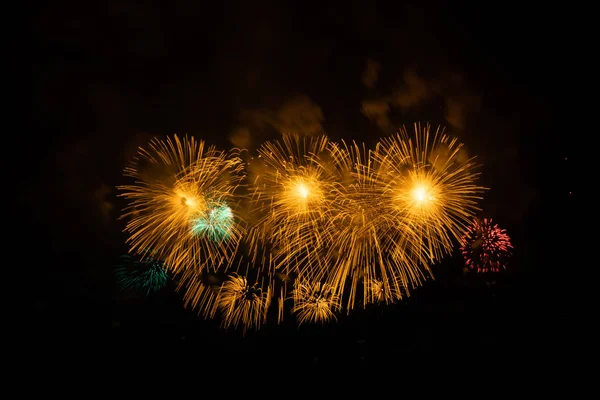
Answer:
[{"xmin": 375, "ymin": 124, "xmax": 485, "ymax": 263}]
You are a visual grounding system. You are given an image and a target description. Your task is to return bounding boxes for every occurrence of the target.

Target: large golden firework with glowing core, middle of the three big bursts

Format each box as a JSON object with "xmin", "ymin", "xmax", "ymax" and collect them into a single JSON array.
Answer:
[{"xmin": 249, "ymin": 135, "xmax": 333, "ymax": 272}]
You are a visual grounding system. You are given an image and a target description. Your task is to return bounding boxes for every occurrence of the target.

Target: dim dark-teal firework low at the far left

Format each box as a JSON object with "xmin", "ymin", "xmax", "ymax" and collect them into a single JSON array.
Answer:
[{"xmin": 115, "ymin": 254, "xmax": 169, "ymax": 295}]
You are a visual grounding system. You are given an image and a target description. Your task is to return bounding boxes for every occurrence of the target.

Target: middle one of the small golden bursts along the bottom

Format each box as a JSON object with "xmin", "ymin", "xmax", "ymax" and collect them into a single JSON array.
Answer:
[{"xmin": 292, "ymin": 280, "xmax": 341, "ymax": 325}]
